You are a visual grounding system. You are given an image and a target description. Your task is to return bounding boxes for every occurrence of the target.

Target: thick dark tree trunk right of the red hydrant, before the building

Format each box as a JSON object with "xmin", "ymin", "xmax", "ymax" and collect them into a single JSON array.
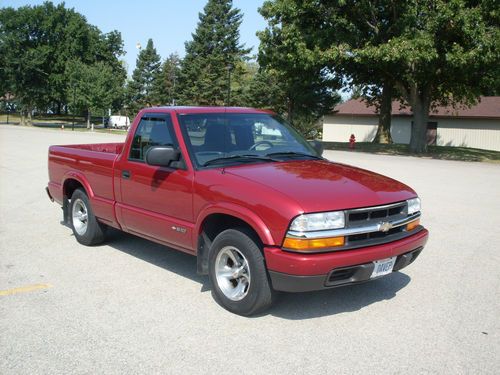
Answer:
[{"xmin": 410, "ymin": 89, "xmax": 431, "ymax": 154}]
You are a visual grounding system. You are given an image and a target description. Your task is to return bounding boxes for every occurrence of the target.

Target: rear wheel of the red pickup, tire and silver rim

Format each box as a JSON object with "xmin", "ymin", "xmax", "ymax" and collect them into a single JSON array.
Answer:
[{"xmin": 69, "ymin": 189, "xmax": 106, "ymax": 246}]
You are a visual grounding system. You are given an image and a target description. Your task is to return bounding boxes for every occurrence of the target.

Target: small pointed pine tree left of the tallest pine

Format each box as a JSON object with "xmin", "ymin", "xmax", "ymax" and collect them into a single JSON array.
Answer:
[{"xmin": 127, "ymin": 39, "xmax": 161, "ymax": 110}]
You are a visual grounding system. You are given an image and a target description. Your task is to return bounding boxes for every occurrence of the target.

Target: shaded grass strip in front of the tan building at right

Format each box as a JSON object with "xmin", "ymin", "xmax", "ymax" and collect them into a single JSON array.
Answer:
[{"xmin": 323, "ymin": 142, "xmax": 500, "ymax": 163}]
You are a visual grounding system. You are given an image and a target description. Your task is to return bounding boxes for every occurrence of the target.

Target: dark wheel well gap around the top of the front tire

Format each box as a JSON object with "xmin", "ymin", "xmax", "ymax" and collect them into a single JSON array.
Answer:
[{"xmin": 197, "ymin": 214, "xmax": 262, "ymax": 275}]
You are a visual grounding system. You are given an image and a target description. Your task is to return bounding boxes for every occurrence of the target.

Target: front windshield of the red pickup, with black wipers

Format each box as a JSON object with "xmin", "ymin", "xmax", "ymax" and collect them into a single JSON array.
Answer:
[{"xmin": 178, "ymin": 113, "xmax": 319, "ymax": 167}]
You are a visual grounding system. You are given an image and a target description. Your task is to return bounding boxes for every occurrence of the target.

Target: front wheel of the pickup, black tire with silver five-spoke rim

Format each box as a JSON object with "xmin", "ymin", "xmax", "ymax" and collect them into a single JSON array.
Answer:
[{"xmin": 208, "ymin": 228, "xmax": 274, "ymax": 316}]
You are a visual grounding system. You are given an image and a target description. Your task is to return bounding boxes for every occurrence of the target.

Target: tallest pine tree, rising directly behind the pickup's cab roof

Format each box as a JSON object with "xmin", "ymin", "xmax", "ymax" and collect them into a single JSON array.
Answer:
[{"xmin": 179, "ymin": 0, "xmax": 250, "ymax": 105}]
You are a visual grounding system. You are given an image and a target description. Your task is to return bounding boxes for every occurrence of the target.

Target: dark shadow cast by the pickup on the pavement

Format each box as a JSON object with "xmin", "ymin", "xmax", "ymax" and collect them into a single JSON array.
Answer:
[{"xmin": 106, "ymin": 229, "xmax": 411, "ymax": 320}]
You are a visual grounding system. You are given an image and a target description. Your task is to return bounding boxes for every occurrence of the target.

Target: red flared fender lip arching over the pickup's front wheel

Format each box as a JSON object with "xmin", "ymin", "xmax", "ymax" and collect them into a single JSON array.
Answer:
[{"xmin": 193, "ymin": 202, "xmax": 276, "ymax": 249}]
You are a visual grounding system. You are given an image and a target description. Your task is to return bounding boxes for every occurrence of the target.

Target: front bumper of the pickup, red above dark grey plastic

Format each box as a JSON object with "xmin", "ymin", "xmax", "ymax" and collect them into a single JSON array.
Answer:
[{"xmin": 264, "ymin": 229, "xmax": 429, "ymax": 292}]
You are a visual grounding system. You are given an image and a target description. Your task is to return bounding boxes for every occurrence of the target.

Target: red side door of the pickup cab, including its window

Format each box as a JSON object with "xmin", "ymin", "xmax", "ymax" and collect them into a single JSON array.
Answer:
[{"xmin": 115, "ymin": 113, "xmax": 194, "ymax": 252}]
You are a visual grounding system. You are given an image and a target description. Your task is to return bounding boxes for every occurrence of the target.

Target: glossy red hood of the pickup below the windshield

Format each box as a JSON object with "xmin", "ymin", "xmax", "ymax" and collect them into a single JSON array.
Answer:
[{"xmin": 225, "ymin": 160, "xmax": 416, "ymax": 212}]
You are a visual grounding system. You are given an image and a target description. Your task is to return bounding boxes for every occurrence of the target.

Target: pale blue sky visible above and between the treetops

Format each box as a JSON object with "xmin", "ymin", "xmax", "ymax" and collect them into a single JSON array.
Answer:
[{"xmin": 0, "ymin": 0, "xmax": 266, "ymax": 75}]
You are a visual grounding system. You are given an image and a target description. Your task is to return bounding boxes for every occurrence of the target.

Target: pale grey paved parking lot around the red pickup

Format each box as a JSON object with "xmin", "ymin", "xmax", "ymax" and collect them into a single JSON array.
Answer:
[{"xmin": 0, "ymin": 125, "xmax": 500, "ymax": 374}]
